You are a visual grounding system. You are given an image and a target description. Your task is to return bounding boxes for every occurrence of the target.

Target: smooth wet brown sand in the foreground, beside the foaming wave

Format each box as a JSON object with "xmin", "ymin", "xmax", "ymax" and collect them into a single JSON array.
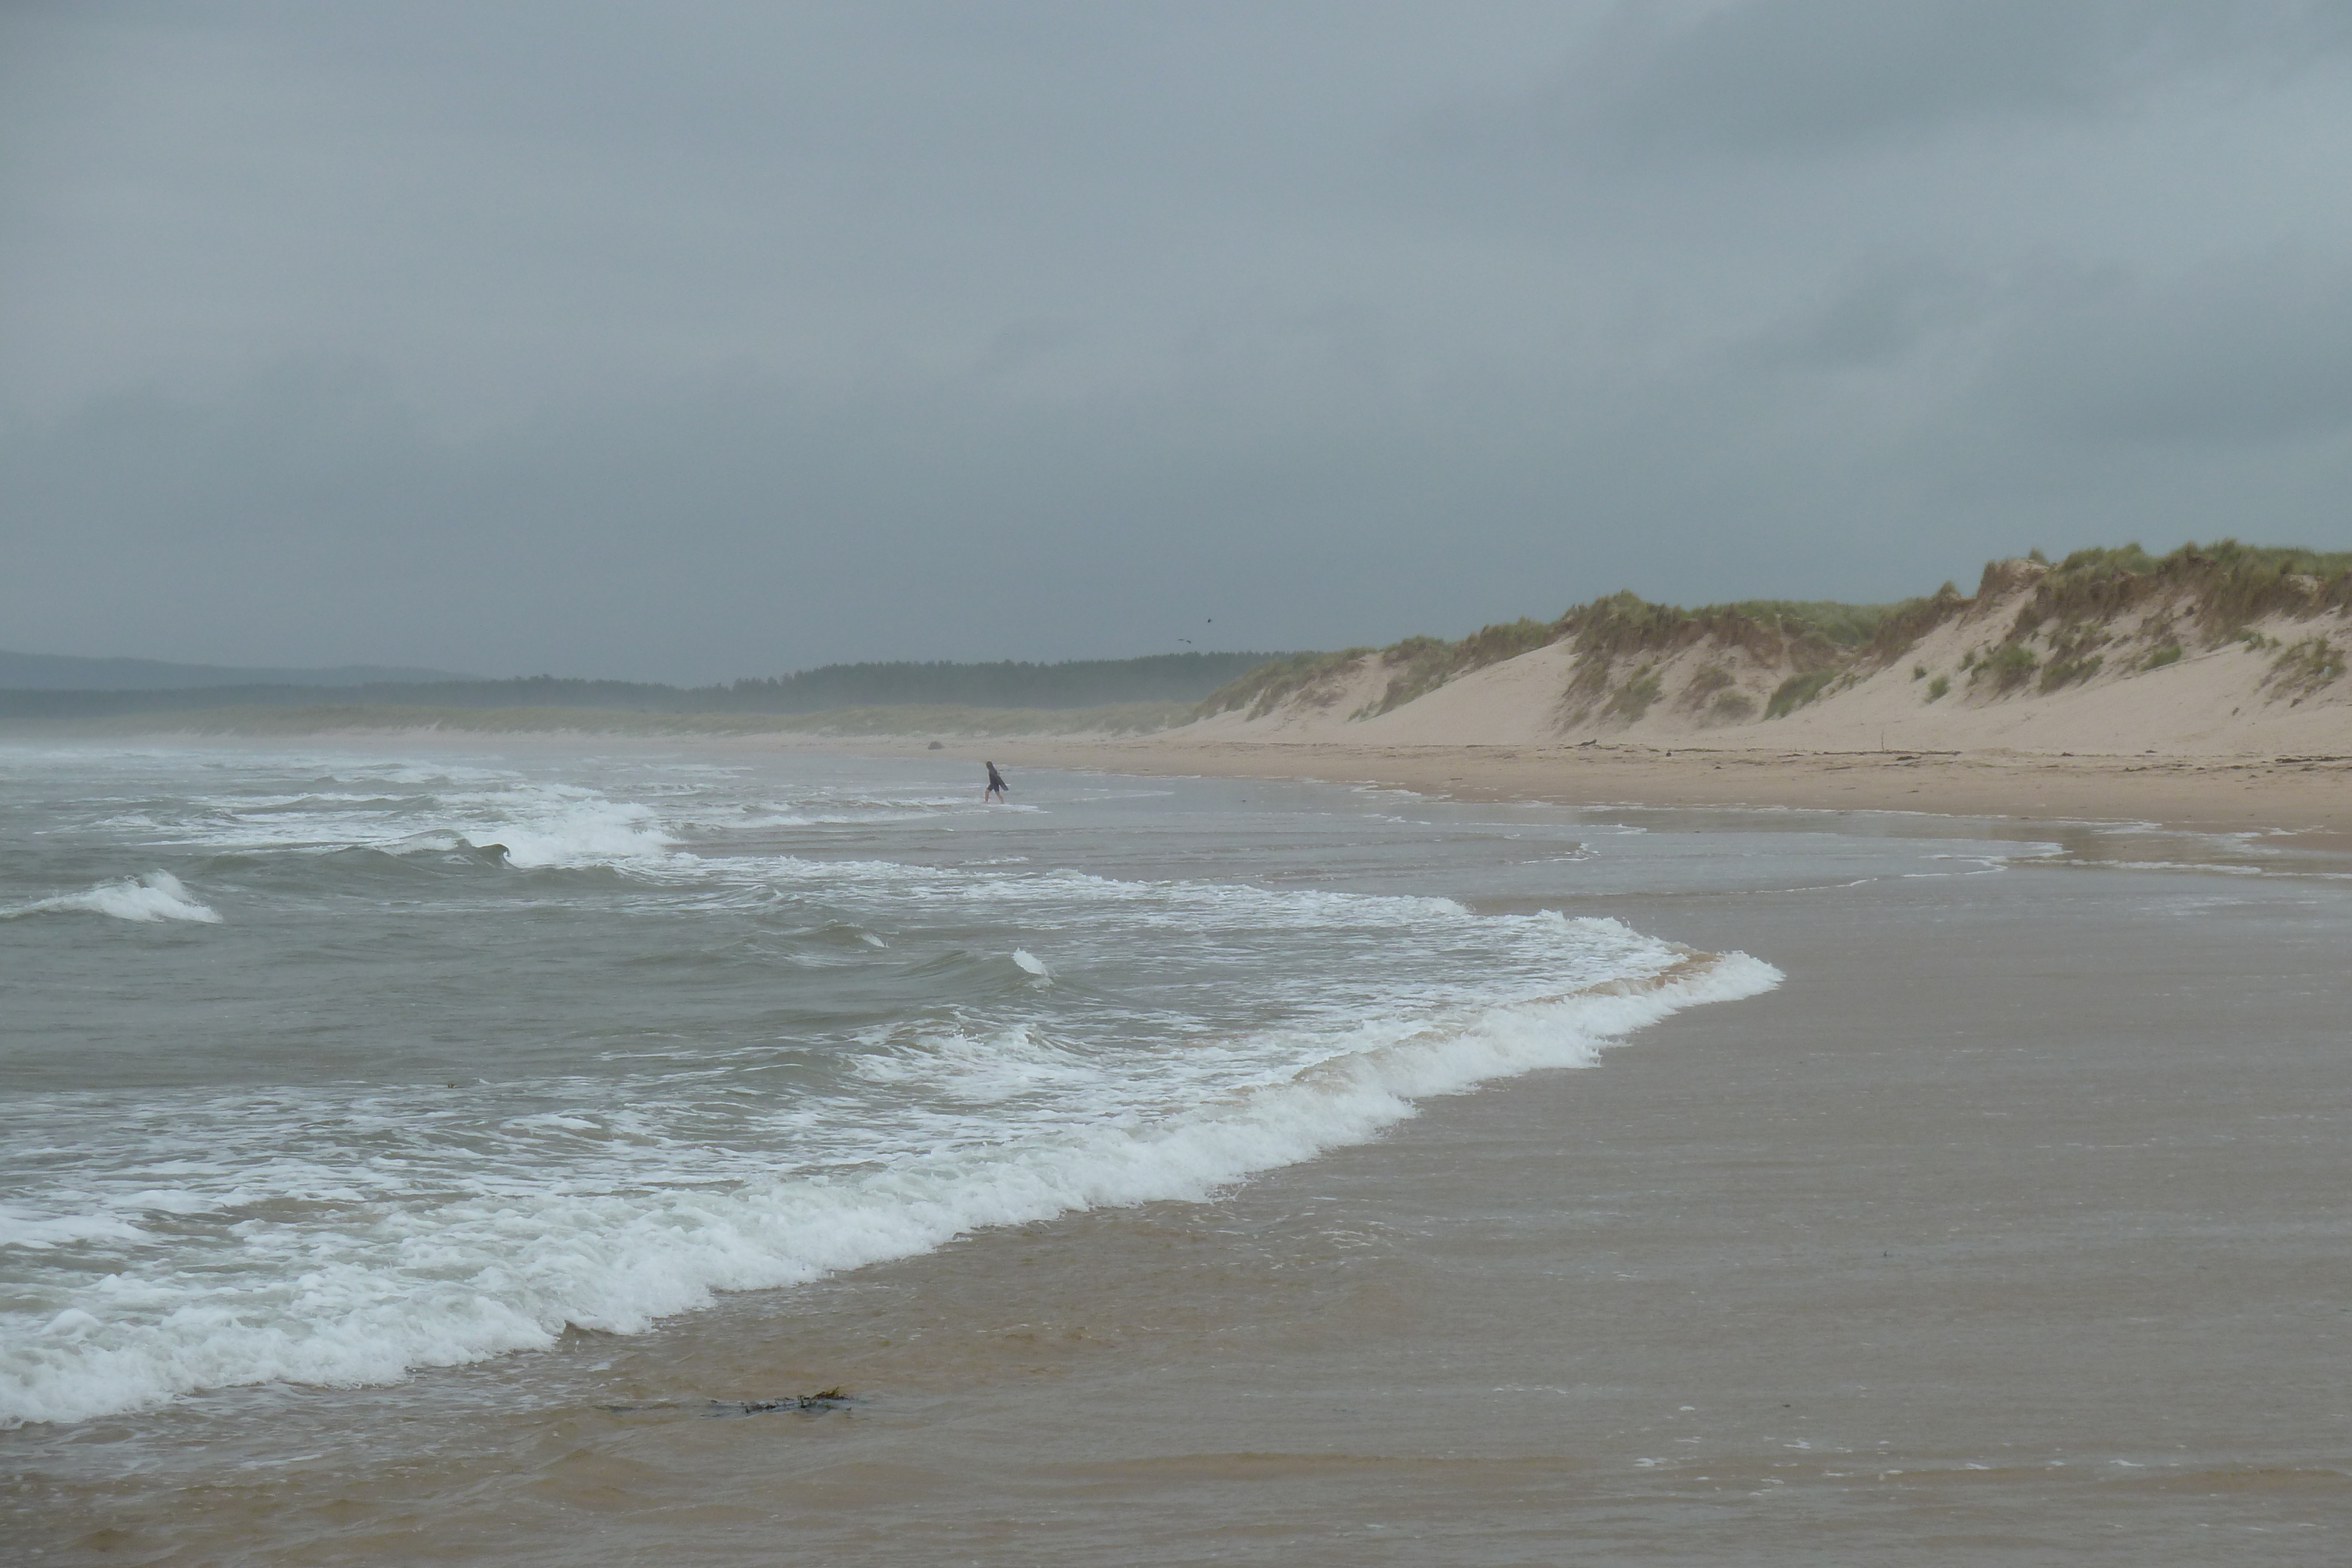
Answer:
[{"xmin": 12, "ymin": 804, "xmax": 2352, "ymax": 1566}]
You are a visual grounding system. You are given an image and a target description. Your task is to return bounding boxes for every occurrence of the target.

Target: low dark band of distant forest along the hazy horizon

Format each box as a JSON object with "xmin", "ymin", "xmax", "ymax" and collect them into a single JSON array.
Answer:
[{"xmin": 0, "ymin": 654, "xmax": 1279, "ymax": 720}]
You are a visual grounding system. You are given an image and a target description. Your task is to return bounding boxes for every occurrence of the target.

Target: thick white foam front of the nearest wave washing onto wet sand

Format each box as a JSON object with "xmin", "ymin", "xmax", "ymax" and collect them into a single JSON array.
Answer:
[{"xmin": 0, "ymin": 954, "xmax": 1780, "ymax": 1425}]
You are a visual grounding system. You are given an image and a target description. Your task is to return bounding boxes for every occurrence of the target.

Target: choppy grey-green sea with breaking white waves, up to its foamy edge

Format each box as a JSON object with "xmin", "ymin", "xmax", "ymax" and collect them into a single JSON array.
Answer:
[{"xmin": 0, "ymin": 748, "xmax": 1778, "ymax": 1425}]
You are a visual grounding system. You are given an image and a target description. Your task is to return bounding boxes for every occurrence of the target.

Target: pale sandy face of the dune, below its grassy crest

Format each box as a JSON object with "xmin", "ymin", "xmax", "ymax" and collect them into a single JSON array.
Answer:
[{"xmin": 1169, "ymin": 562, "xmax": 2352, "ymax": 757}]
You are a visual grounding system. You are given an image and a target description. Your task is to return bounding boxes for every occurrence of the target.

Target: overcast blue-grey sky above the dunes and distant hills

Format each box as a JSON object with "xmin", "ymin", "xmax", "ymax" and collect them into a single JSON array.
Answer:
[{"xmin": 0, "ymin": 0, "xmax": 2352, "ymax": 680}]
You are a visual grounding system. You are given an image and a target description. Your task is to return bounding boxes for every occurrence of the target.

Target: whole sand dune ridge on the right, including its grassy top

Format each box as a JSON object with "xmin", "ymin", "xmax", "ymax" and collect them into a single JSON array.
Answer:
[{"xmin": 1190, "ymin": 548, "xmax": 2352, "ymax": 755}]
